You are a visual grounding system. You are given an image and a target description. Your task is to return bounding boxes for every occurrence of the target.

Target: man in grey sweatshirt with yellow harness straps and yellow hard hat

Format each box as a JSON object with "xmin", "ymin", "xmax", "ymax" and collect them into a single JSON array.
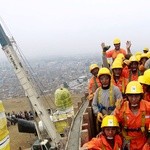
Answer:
[{"xmin": 92, "ymin": 68, "xmax": 122, "ymax": 132}]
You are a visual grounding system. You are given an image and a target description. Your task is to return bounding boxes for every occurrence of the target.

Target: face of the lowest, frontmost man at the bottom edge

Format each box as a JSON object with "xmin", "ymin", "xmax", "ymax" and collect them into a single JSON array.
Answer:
[{"xmin": 103, "ymin": 127, "xmax": 117, "ymax": 139}]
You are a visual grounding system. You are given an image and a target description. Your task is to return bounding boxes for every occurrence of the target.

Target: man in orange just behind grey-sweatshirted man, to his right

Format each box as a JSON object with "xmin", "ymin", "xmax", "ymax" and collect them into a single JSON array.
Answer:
[{"xmin": 111, "ymin": 58, "xmax": 128, "ymax": 95}]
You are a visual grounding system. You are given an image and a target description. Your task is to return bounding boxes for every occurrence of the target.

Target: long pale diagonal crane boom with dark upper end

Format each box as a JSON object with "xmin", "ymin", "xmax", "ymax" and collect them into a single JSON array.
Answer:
[{"xmin": 0, "ymin": 24, "xmax": 61, "ymax": 147}]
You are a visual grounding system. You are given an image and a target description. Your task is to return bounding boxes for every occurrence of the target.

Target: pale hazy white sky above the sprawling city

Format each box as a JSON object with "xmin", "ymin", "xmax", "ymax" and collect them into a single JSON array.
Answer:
[{"xmin": 0, "ymin": 0, "xmax": 150, "ymax": 58}]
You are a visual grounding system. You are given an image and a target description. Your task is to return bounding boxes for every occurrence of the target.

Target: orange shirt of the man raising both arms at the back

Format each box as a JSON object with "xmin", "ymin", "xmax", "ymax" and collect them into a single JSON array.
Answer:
[{"xmin": 106, "ymin": 48, "xmax": 126, "ymax": 59}]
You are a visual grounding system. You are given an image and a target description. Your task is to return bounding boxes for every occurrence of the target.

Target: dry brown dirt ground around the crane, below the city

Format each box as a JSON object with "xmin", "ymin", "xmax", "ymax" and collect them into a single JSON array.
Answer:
[{"xmin": 3, "ymin": 95, "xmax": 83, "ymax": 150}]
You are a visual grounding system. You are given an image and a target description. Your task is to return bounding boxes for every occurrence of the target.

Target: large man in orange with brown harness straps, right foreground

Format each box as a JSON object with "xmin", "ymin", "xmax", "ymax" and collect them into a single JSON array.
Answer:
[{"xmin": 114, "ymin": 81, "xmax": 150, "ymax": 150}]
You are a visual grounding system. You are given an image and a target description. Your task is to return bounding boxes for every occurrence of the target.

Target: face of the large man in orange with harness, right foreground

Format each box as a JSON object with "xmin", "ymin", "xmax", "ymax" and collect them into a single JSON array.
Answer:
[{"xmin": 127, "ymin": 94, "xmax": 141, "ymax": 107}]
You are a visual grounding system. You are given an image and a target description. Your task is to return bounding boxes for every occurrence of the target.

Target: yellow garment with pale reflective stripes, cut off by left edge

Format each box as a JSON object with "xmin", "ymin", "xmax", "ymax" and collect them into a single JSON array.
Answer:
[{"xmin": 0, "ymin": 101, "xmax": 10, "ymax": 150}]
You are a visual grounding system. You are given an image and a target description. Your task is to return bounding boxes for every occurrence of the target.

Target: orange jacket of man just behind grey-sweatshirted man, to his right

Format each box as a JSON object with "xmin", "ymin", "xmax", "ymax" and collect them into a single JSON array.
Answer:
[{"xmin": 111, "ymin": 76, "xmax": 128, "ymax": 94}]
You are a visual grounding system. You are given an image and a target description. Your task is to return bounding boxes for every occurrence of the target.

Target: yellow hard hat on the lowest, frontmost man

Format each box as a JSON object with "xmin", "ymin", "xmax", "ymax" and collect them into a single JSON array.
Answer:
[{"xmin": 101, "ymin": 115, "xmax": 119, "ymax": 128}]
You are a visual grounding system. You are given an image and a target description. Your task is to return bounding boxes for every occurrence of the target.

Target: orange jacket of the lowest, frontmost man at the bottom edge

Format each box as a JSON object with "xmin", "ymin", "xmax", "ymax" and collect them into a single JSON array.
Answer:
[{"xmin": 83, "ymin": 134, "xmax": 122, "ymax": 150}]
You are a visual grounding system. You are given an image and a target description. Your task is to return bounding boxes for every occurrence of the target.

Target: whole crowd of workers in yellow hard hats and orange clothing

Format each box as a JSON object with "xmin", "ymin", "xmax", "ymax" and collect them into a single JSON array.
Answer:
[{"xmin": 81, "ymin": 38, "xmax": 150, "ymax": 150}]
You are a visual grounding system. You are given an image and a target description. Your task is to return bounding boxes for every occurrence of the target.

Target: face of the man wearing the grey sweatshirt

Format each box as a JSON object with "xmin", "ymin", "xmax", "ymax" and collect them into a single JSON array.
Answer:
[{"xmin": 99, "ymin": 74, "xmax": 110, "ymax": 88}]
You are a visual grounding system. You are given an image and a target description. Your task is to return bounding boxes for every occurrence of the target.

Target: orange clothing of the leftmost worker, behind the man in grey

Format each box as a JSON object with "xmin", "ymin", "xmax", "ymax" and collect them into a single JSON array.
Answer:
[{"xmin": 88, "ymin": 76, "xmax": 101, "ymax": 95}]
